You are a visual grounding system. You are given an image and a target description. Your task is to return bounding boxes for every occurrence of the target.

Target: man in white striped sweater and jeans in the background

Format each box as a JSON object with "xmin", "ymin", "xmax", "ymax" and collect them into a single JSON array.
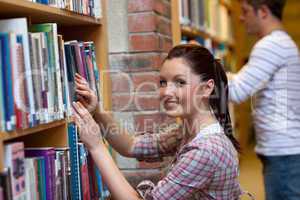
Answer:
[{"xmin": 228, "ymin": 0, "xmax": 300, "ymax": 200}]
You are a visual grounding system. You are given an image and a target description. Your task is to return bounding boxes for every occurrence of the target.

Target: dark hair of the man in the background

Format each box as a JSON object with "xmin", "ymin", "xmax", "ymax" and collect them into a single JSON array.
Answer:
[{"xmin": 246, "ymin": 0, "xmax": 286, "ymax": 20}]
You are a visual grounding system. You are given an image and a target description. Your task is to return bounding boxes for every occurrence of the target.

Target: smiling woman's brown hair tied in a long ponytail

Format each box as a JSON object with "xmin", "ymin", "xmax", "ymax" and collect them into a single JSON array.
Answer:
[{"xmin": 165, "ymin": 44, "xmax": 240, "ymax": 151}]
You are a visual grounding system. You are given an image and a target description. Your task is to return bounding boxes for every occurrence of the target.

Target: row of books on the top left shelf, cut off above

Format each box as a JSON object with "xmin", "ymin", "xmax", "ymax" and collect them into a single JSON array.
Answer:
[{"xmin": 28, "ymin": 0, "xmax": 102, "ymax": 19}]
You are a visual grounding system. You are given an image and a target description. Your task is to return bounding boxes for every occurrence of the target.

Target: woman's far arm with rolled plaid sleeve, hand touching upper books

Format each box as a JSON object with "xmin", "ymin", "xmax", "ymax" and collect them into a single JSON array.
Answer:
[{"xmin": 75, "ymin": 74, "xmax": 181, "ymax": 160}]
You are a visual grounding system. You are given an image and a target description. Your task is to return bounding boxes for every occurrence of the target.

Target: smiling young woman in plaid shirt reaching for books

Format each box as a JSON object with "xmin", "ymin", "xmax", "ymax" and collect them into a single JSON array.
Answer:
[{"xmin": 73, "ymin": 44, "xmax": 242, "ymax": 200}]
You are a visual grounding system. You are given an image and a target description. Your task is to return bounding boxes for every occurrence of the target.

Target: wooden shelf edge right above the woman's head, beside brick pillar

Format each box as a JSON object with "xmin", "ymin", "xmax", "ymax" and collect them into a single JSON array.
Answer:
[{"xmin": 181, "ymin": 25, "xmax": 234, "ymax": 47}]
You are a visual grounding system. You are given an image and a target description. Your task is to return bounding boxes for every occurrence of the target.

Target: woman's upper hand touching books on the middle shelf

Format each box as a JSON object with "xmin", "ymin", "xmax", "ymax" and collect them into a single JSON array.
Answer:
[{"xmin": 75, "ymin": 73, "xmax": 98, "ymax": 113}]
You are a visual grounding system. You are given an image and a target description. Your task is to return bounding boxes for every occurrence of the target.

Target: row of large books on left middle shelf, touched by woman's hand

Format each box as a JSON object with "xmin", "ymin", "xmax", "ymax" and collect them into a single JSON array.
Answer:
[{"xmin": 0, "ymin": 18, "xmax": 99, "ymax": 131}]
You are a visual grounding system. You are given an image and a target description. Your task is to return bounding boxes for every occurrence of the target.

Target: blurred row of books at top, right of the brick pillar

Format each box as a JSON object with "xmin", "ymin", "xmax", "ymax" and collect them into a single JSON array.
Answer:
[{"xmin": 178, "ymin": 0, "xmax": 232, "ymax": 41}]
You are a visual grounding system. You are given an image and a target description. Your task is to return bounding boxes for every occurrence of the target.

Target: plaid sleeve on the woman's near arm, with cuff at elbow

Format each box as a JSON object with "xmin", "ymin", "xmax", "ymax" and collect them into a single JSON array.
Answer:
[{"xmin": 137, "ymin": 149, "xmax": 216, "ymax": 200}]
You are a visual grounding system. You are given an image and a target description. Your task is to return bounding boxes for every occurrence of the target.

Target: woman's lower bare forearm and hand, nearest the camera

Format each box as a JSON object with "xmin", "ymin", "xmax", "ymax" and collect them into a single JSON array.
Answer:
[{"xmin": 73, "ymin": 102, "xmax": 140, "ymax": 200}]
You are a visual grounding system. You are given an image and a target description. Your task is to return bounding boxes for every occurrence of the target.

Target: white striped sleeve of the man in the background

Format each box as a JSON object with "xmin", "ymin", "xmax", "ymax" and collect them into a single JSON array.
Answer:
[{"xmin": 228, "ymin": 40, "xmax": 285, "ymax": 103}]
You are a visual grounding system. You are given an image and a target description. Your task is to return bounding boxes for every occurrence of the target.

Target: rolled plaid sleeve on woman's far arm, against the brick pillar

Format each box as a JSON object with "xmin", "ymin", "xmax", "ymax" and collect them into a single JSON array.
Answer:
[{"xmin": 132, "ymin": 126, "xmax": 183, "ymax": 161}]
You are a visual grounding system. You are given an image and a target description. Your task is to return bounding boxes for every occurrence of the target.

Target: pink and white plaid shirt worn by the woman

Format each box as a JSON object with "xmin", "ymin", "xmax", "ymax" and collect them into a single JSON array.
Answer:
[{"xmin": 133, "ymin": 124, "xmax": 242, "ymax": 200}]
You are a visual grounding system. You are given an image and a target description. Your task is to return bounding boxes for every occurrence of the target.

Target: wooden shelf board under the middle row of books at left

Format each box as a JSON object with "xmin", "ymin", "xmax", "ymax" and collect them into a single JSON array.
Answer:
[{"xmin": 0, "ymin": 119, "xmax": 67, "ymax": 142}]
